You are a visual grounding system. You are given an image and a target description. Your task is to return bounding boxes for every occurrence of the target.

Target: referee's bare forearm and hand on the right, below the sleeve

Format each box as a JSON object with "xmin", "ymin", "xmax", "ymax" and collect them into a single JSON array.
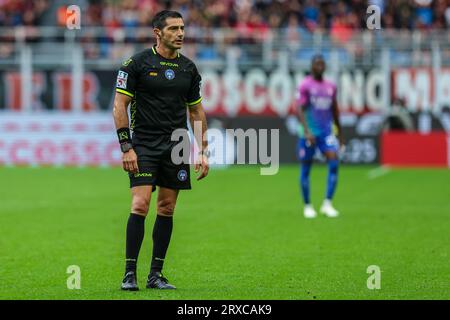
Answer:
[{"xmin": 189, "ymin": 102, "xmax": 209, "ymax": 180}]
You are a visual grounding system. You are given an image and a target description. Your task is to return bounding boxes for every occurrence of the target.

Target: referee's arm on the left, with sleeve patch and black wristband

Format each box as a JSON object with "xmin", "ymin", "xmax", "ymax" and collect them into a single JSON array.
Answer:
[{"xmin": 113, "ymin": 59, "xmax": 139, "ymax": 173}]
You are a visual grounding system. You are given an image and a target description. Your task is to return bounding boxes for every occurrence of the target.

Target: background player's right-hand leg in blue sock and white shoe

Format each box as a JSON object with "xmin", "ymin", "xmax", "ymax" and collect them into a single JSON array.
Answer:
[{"xmin": 319, "ymin": 136, "xmax": 339, "ymax": 217}]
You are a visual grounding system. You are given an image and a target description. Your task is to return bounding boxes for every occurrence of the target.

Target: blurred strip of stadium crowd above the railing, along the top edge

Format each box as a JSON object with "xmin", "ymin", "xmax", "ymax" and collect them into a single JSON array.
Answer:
[{"xmin": 0, "ymin": 0, "xmax": 450, "ymax": 32}]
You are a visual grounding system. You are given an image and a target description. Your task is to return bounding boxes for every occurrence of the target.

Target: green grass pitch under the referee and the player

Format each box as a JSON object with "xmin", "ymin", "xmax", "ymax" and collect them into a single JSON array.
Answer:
[{"xmin": 0, "ymin": 165, "xmax": 450, "ymax": 299}]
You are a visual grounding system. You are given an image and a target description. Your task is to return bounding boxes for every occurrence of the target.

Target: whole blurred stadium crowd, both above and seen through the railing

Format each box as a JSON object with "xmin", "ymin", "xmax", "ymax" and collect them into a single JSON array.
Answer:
[{"xmin": 0, "ymin": 0, "xmax": 450, "ymax": 60}]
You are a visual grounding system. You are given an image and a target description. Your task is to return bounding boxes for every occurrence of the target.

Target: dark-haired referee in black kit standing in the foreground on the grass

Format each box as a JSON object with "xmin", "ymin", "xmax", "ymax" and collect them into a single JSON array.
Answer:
[{"xmin": 113, "ymin": 10, "xmax": 209, "ymax": 291}]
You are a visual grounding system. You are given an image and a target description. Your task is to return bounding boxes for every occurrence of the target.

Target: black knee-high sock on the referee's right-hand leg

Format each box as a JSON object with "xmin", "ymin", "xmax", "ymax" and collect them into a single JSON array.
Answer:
[{"xmin": 150, "ymin": 215, "xmax": 173, "ymax": 272}]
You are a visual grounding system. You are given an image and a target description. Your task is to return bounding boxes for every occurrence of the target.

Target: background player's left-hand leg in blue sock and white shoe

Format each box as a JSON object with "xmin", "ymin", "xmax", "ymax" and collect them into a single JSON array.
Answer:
[{"xmin": 298, "ymin": 138, "xmax": 317, "ymax": 218}]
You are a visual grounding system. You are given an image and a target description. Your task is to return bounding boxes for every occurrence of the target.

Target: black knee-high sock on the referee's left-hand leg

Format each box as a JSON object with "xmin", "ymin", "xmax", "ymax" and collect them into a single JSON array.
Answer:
[{"xmin": 125, "ymin": 213, "xmax": 145, "ymax": 273}]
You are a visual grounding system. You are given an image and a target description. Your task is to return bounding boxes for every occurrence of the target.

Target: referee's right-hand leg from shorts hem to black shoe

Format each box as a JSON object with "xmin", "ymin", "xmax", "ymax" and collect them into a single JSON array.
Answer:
[{"xmin": 147, "ymin": 187, "xmax": 178, "ymax": 289}]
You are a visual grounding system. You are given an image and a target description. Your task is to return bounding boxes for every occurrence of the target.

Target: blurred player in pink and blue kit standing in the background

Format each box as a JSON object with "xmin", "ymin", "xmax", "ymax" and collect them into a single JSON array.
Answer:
[{"xmin": 298, "ymin": 55, "xmax": 344, "ymax": 218}]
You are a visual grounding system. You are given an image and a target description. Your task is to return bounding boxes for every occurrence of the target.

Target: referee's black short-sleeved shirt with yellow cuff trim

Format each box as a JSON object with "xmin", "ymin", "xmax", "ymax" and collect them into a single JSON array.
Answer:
[{"xmin": 116, "ymin": 47, "xmax": 202, "ymax": 140}]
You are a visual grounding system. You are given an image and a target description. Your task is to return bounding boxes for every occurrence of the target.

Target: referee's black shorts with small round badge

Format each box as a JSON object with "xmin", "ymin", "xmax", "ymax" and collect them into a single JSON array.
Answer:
[{"xmin": 128, "ymin": 140, "xmax": 191, "ymax": 191}]
